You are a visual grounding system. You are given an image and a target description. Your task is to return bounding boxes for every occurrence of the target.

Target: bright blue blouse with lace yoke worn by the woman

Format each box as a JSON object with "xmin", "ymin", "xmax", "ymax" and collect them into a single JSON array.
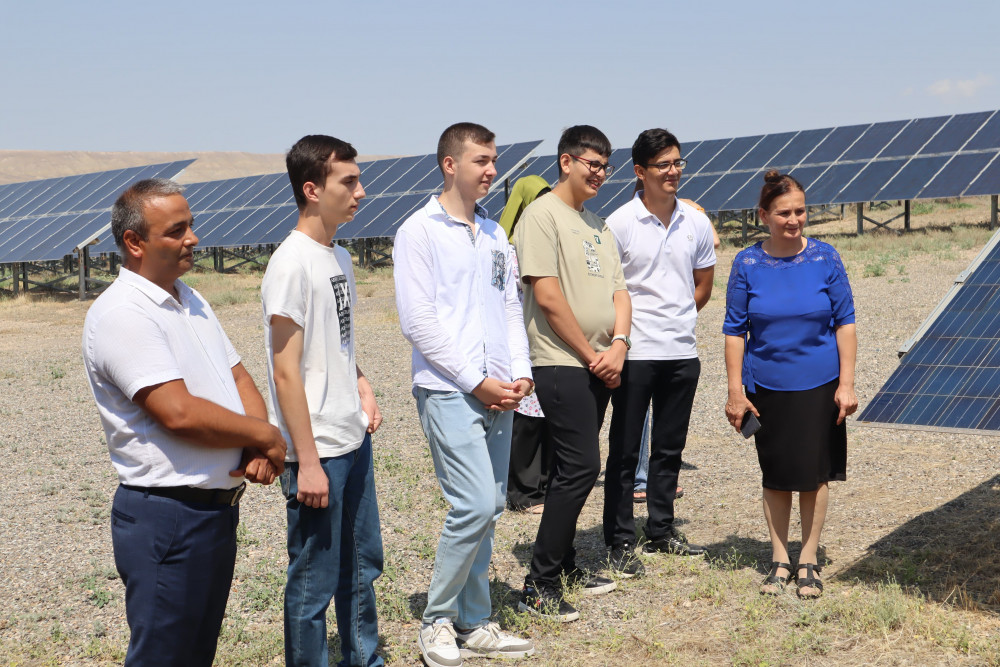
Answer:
[{"xmin": 722, "ymin": 239, "xmax": 854, "ymax": 392}]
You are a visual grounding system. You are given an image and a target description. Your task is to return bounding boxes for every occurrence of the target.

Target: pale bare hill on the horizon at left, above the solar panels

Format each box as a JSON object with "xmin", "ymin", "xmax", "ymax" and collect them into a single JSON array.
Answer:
[{"xmin": 0, "ymin": 150, "xmax": 392, "ymax": 185}]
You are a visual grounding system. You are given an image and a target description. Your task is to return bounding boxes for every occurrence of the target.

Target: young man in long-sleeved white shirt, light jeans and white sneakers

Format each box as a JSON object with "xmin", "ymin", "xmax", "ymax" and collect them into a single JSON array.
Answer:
[{"xmin": 392, "ymin": 123, "xmax": 534, "ymax": 667}]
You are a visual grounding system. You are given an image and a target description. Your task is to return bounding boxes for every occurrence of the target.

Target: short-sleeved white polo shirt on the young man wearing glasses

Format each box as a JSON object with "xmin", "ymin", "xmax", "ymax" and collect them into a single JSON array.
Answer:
[{"xmin": 605, "ymin": 192, "xmax": 715, "ymax": 360}]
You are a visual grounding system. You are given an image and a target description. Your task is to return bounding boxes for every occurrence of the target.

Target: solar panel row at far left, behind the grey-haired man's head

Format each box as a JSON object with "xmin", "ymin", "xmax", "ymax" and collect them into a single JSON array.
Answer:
[{"xmin": 0, "ymin": 160, "xmax": 194, "ymax": 264}]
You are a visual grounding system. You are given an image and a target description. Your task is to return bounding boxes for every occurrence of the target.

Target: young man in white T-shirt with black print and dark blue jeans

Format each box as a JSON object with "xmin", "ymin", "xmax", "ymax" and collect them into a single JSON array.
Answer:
[{"xmin": 260, "ymin": 135, "xmax": 384, "ymax": 667}]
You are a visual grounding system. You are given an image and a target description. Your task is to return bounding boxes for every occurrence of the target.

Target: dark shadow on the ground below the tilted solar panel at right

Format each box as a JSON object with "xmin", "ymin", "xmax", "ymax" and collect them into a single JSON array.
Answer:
[{"xmin": 837, "ymin": 475, "xmax": 1000, "ymax": 608}]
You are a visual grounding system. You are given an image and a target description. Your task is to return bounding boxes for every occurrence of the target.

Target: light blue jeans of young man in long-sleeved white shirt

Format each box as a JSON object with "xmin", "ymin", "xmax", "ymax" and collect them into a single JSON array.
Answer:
[{"xmin": 415, "ymin": 387, "xmax": 514, "ymax": 629}]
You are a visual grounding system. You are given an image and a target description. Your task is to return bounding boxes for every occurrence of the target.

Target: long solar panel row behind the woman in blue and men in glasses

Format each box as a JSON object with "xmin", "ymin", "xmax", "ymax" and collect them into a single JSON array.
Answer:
[{"xmin": 504, "ymin": 111, "xmax": 1000, "ymax": 217}]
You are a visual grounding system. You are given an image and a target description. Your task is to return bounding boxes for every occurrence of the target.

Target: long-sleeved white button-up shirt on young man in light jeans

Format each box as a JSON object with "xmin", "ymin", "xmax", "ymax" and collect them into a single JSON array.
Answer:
[{"xmin": 392, "ymin": 196, "xmax": 531, "ymax": 393}]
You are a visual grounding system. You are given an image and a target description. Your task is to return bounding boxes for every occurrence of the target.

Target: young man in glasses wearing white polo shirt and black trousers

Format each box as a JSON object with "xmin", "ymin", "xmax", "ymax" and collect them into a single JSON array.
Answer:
[{"xmin": 604, "ymin": 129, "xmax": 715, "ymax": 576}]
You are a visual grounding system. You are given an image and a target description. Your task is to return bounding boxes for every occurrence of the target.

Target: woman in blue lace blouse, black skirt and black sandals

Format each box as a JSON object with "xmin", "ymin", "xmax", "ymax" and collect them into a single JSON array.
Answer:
[{"xmin": 722, "ymin": 170, "xmax": 858, "ymax": 597}]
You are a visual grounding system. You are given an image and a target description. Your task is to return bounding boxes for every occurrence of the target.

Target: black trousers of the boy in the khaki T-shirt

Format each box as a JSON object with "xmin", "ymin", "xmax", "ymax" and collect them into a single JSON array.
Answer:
[{"xmin": 525, "ymin": 366, "xmax": 612, "ymax": 586}]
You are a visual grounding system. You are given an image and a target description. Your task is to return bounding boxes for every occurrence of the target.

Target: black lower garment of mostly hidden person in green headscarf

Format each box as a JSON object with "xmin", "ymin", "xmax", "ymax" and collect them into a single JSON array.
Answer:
[{"xmin": 507, "ymin": 412, "xmax": 552, "ymax": 510}]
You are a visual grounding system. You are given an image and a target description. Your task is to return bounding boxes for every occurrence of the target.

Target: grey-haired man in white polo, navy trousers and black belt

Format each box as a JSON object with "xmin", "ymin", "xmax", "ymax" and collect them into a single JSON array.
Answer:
[{"xmin": 83, "ymin": 179, "xmax": 285, "ymax": 667}]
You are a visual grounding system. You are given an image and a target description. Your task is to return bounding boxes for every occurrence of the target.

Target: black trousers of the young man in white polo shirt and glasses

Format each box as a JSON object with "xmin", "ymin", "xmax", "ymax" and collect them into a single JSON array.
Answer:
[{"xmin": 604, "ymin": 359, "xmax": 701, "ymax": 546}]
